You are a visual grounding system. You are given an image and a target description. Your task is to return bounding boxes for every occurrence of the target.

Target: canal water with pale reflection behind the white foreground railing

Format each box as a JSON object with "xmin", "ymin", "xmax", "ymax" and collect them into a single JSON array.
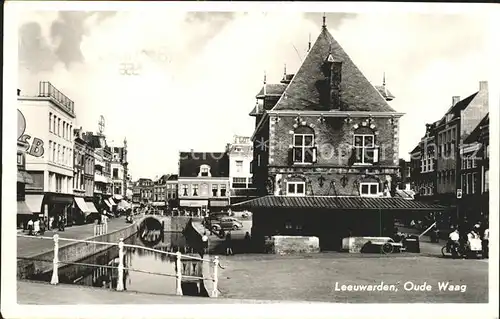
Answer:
[{"xmin": 30, "ymin": 231, "xmax": 200, "ymax": 294}]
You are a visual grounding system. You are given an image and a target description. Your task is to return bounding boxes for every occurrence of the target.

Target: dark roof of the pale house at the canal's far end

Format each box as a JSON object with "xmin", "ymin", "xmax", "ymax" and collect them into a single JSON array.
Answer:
[{"xmin": 179, "ymin": 152, "xmax": 229, "ymax": 178}]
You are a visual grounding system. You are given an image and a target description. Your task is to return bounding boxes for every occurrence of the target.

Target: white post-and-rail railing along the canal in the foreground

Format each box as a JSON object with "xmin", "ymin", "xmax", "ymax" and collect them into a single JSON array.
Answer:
[{"xmin": 17, "ymin": 234, "xmax": 223, "ymax": 297}]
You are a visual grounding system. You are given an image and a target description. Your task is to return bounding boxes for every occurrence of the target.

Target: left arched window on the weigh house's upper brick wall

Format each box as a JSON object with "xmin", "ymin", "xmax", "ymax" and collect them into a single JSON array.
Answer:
[{"xmin": 293, "ymin": 126, "xmax": 316, "ymax": 164}]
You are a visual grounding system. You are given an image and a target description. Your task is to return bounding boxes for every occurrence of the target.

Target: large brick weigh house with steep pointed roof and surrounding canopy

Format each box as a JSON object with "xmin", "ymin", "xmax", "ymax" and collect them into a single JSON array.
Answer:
[{"xmin": 233, "ymin": 20, "xmax": 443, "ymax": 250}]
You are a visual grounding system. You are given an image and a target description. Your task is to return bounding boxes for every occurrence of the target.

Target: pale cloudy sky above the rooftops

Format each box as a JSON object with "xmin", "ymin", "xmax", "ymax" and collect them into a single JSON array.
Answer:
[{"xmin": 18, "ymin": 8, "xmax": 490, "ymax": 180}]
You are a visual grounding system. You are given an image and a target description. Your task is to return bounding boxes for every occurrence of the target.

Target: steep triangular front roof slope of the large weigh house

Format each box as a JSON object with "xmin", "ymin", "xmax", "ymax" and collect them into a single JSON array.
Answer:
[{"xmin": 273, "ymin": 28, "xmax": 395, "ymax": 112}]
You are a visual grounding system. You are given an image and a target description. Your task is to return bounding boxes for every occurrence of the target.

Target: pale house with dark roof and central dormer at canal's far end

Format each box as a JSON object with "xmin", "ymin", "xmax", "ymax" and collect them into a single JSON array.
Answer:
[{"xmin": 178, "ymin": 152, "xmax": 230, "ymax": 215}]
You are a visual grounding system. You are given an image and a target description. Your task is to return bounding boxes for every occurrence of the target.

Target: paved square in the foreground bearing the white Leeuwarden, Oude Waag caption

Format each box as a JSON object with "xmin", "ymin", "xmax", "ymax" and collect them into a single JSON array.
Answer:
[{"xmin": 219, "ymin": 253, "xmax": 488, "ymax": 303}]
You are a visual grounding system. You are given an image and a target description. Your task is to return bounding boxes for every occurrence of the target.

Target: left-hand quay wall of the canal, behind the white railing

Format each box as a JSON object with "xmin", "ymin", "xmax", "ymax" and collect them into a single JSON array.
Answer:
[{"xmin": 17, "ymin": 224, "xmax": 137, "ymax": 279}]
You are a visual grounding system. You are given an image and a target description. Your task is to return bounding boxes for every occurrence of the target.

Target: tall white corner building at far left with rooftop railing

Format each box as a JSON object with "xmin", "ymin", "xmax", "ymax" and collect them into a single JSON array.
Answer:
[{"xmin": 17, "ymin": 82, "xmax": 76, "ymax": 226}]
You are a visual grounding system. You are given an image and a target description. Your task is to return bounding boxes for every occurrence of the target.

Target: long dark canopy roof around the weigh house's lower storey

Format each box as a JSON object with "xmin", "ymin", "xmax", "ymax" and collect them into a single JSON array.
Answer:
[{"xmin": 232, "ymin": 195, "xmax": 447, "ymax": 211}]
